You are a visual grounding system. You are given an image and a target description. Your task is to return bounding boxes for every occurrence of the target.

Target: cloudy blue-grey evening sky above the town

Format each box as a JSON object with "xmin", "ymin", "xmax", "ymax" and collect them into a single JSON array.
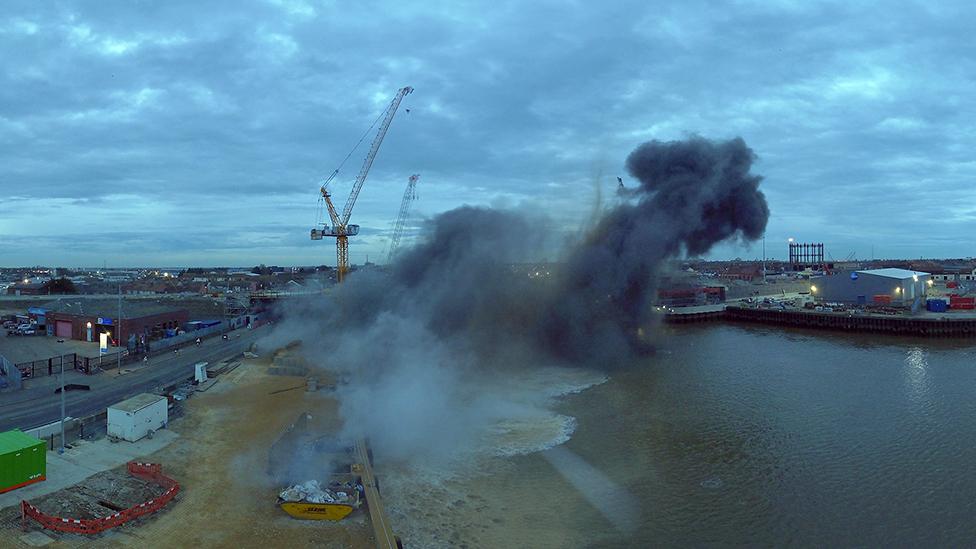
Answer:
[{"xmin": 0, "ymin": 0, "xmax": 976, "ymax": 266}]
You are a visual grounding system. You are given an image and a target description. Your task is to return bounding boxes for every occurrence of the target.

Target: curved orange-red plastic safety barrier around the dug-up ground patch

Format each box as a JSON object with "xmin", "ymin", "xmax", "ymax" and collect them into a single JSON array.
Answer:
[{"xmin": 20, "ymin": 461, "xmax": 180, "ymax": 534}]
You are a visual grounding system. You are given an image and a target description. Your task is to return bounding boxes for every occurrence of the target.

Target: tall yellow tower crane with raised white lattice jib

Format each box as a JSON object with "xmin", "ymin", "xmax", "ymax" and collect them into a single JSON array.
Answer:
[{"xmin": 312, "ymin": 86, "xmax": 413, "ymax": 282}]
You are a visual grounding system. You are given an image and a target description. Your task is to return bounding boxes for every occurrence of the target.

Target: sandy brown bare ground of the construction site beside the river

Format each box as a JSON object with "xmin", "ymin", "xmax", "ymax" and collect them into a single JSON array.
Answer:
[{"xmin": 0, "ymin": 357, "xmax": 374, "ymax": 548}]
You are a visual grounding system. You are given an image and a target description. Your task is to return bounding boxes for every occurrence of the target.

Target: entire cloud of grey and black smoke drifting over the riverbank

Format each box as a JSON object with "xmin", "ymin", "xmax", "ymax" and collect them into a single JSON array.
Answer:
[{"xmin": 267, "ymin": 137, "xmax": 769, "ymax": 463}]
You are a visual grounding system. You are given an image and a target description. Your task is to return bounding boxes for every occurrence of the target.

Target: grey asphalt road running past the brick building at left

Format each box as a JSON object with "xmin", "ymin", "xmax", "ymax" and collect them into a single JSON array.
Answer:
[{"xmin": 0, "ymin": 326, "xmax": 270, "ymax": 432}]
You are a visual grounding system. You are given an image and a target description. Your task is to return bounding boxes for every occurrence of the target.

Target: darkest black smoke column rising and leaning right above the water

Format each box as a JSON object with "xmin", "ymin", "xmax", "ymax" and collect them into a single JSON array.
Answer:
[{"xmin": 543, "ymin": 137, "xmax": 769, "ymax": 363}]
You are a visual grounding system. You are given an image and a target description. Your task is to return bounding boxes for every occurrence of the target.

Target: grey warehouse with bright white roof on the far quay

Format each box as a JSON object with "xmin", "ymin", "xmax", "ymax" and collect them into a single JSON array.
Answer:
[{"xmin": 811, "ymin": 268, "xmax": 931, "ymax": 306}]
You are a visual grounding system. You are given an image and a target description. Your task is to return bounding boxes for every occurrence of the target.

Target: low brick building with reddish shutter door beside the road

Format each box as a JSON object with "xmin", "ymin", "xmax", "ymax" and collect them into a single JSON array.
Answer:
[{"xmin": 43, "ymin": 299, "xmax": 190, "ymax": 348}]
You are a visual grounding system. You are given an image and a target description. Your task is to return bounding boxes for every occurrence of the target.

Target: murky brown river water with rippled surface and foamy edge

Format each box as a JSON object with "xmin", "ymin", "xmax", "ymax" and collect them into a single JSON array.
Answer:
[{"xmin": 392, "ymin": 323, "xmax": 976, "ymax": 547}]
